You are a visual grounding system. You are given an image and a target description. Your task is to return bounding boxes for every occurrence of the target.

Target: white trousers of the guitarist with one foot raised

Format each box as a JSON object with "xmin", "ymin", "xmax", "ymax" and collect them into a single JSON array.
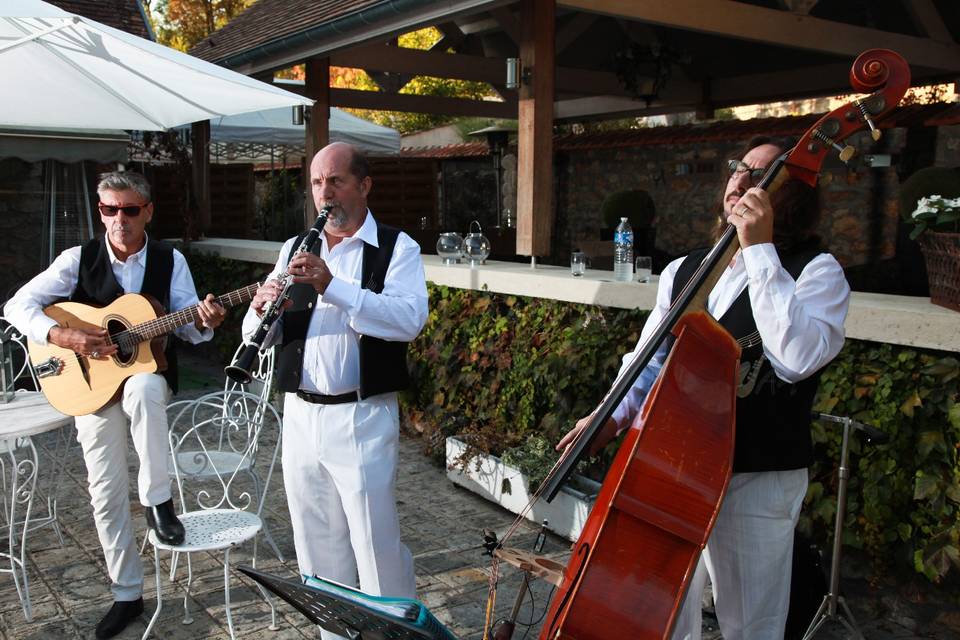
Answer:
[{"xmin": 76, "ymin": 373, "xmax": 171, "ymax": 601}]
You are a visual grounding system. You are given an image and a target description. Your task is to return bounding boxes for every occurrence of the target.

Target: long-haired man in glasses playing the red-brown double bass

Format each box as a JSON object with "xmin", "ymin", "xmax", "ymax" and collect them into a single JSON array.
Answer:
[{"xmin": 557, "ymin": 137, "xmax": 850, "ymax": 640}]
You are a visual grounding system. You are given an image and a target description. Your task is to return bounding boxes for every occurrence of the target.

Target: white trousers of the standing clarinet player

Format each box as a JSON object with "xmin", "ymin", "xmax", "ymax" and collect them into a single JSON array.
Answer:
[{"xmin": 283, "ymin": 393, "xmax": 416, "ymax": 638}]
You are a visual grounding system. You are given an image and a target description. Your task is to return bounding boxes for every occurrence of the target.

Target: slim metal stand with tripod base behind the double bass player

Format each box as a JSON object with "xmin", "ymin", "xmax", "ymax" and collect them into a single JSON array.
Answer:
[{"xmin": 803, "ymin": 413, "xmax": 887, "ymax": 640}]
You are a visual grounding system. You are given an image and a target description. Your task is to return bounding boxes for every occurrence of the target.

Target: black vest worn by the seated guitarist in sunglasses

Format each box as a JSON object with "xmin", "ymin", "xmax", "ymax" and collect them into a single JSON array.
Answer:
[{"xmin": 70, "ymin": 238, "xmax": 177, "ymax": 393}]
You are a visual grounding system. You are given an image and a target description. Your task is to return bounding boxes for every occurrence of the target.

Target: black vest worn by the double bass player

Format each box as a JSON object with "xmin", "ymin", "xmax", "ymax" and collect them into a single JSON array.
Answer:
[{"xmin": 671, "ymin": 245, "xmax": 822, "ymax": 472}]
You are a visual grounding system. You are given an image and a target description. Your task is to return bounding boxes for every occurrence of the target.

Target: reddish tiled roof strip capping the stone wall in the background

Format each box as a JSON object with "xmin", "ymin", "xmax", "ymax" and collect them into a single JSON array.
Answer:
[{"xmin": 400, "ymin": 104, "xmax": 960, "ymax": 159}]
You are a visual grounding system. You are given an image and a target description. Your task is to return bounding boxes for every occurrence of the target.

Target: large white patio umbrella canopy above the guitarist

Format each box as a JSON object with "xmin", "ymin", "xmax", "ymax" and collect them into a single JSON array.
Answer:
[{"xmin": 0, "ymin": 0, "xmax": 312, "ymax": 131}]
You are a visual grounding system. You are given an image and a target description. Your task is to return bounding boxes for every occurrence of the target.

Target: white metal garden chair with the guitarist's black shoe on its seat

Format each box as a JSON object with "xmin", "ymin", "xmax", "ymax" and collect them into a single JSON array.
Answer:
[{"xmin": 143, "ymin": 390, "xmax": 280, "ymax": 638}]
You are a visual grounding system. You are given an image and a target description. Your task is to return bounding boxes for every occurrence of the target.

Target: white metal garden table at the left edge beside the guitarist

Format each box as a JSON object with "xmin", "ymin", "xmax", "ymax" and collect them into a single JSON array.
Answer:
[{"xmin": 0, "ymin": 391, "xmax": 73, "ymax": 622}]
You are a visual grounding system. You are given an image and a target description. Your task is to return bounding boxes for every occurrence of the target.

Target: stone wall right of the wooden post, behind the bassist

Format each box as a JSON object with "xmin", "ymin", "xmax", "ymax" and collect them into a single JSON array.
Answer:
[{"xmin": 554, "ymin": 129, "xmax": 904, "ymax": 266}]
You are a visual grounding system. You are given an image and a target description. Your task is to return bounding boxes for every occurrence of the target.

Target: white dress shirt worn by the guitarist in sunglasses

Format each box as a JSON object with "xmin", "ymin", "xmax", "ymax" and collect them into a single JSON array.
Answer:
[{"xmin": 3, "ymin": 234, "xmax": 213, "ymax": 345}]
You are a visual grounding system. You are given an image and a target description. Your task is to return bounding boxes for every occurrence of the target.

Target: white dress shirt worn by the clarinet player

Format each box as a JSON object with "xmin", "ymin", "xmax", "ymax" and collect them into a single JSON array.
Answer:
[{"xmin": 243, "ymin": 210, "xmax": 427, "ymax": 395}]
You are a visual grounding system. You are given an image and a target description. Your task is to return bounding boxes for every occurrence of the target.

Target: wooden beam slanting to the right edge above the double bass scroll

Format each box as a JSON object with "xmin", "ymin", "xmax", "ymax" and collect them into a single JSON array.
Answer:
[{"xmin": 557, "ymin": 0, "xmax": 960, "ymax": 71}]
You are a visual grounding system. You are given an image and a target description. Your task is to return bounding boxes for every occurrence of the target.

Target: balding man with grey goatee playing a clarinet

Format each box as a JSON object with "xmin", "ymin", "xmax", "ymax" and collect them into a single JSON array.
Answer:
[{"xmin": 243, "ymin": 143, "xmax": 427, "ymax": 638}]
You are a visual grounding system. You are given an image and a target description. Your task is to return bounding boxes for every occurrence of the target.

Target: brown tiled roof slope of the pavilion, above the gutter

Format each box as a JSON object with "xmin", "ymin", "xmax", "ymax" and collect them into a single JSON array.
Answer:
[{"xmin": 190, "ymin": 0, "xmax": 383, "ymax": 62}]
